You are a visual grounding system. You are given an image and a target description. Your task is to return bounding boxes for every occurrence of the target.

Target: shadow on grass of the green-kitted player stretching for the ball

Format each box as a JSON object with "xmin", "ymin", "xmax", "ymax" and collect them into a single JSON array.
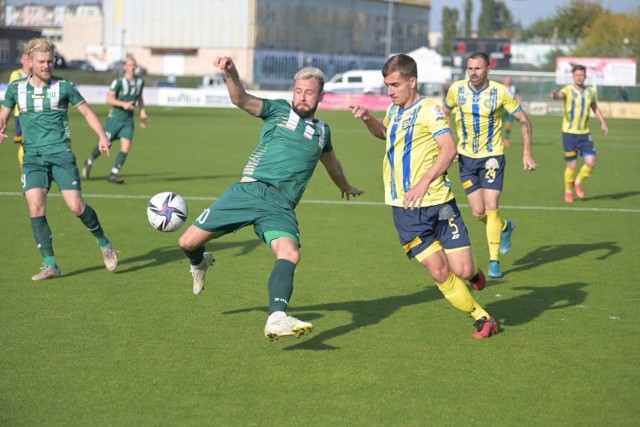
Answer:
[{"xmin": 223, "ymin": 285, "xmax": 444, "ymax": 350}]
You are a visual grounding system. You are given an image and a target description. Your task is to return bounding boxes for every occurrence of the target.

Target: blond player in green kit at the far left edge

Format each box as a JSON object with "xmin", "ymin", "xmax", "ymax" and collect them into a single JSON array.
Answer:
[{"xmin": 0, "ymin": 38, "xmax": 118, "ymax": 280}]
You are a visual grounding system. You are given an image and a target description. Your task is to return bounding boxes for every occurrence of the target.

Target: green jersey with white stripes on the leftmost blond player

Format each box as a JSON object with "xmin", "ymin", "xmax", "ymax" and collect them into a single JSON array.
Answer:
[{"xmin": 2, "ymin": 76, "xmax": 85, "ymax": 154}]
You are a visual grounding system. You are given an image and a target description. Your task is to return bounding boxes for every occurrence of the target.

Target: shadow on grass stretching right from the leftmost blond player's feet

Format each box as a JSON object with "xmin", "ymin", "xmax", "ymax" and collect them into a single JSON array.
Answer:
[{"xmin": 64, "ymin": 239, "xmax": 263, "ymax": 276}]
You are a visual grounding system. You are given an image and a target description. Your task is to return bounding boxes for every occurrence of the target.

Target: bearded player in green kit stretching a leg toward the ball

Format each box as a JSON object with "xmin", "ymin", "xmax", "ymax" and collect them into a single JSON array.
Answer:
[{"xmin": 179, "ymin": 57, "xmax": 363, "ymax": 341}]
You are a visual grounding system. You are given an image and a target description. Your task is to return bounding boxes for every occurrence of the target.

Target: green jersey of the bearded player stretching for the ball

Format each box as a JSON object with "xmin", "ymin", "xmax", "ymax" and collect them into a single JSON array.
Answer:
[{"xmin": 242, "ymin": 99, "xmax": 333, "ymax": 205}]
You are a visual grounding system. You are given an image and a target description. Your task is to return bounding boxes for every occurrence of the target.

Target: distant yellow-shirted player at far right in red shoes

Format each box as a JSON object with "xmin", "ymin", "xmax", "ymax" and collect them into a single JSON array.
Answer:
[{"xmin": 551, "ymin": 65, "xmax": 609, "ymax": 203}]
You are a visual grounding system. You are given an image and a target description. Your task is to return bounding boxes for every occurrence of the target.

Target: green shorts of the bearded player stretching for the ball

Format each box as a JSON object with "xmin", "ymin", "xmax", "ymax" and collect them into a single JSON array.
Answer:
[{"xmin": 193, "ymin": 181, "xmax": 300, "ymax": 246}]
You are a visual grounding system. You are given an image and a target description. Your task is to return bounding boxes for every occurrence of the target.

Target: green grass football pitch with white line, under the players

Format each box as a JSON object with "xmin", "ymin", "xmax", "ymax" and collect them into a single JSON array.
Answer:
[{"xmin": 0, "ymin": 106, "xmax": 640, "ymax": 426}]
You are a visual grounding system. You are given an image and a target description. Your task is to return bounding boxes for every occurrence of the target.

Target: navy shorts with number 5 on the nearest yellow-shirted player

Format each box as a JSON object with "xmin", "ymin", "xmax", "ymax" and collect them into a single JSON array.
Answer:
[{"xmin": 393, "ymin": 199, "xmax": 471, "ymax": 259}]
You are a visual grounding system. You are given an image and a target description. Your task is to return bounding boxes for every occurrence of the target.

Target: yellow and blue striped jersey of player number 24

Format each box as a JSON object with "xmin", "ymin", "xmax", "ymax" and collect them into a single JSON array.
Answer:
[{"xmin": 444, "ymin": 79, "xmax": 522, "ymax": 159}]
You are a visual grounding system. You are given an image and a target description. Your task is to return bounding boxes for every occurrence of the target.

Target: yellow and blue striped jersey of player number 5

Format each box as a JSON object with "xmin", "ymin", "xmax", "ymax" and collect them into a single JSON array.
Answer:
[{"xmin": 382, "ymin": 97, "xmax": 453, "ymax": 211}]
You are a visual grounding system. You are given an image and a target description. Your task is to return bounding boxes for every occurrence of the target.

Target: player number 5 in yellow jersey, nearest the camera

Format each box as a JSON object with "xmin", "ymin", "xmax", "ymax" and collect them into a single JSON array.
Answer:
[{"xmin": 351, "ymin": 54, "xmax": 498, "ymax": 339}]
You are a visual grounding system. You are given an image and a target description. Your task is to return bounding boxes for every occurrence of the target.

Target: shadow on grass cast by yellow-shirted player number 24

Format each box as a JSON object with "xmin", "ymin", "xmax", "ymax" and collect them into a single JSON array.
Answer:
[{"xmin": 504, "ymin": 242, "xmax": 622, "ymax": 274}]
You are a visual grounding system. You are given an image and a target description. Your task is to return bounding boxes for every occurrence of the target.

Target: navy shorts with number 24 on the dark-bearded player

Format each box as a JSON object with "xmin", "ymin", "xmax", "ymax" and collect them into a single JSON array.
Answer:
[{"xmin": 458, "ymin": 154, "xmax": 507, "ymax": 194}]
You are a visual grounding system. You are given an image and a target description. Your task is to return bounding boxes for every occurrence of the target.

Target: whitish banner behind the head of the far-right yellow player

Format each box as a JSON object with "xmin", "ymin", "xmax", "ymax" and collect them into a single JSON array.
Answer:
[{"xmin": 556, "ymin": 56, "xmax": 637, "ymax": 86}]
